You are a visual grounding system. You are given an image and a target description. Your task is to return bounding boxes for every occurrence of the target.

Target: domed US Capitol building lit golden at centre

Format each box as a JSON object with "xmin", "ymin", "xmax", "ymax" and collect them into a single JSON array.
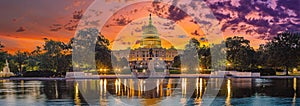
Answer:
[{"xmin": 113, "ymin": 14, "xmax": 178, "ymax": 69}]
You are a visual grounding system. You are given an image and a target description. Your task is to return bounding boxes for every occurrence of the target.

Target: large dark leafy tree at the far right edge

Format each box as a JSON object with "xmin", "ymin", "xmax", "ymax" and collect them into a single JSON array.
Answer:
[{"xmin": 265, "ymin": 32, "xmax": 300, "ymax": 75}]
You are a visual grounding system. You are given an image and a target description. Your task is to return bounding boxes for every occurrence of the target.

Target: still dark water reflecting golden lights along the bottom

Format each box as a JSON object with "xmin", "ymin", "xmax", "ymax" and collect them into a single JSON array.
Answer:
[{"xmin": 0, "ymin": 78, "xmax": 300, "ymax": 106}]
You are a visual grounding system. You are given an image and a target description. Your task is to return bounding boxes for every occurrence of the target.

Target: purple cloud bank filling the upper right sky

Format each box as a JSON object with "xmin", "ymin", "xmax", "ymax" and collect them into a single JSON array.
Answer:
[{"xmin": 206, "ymin": 0, "xmax": 300, "ymax": 39}]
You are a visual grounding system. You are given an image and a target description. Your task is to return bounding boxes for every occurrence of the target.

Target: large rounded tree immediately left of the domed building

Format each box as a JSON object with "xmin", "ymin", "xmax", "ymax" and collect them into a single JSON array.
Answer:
[{"xmin": 70, "ymin": 28, "xmax": 115, "ymax": 70}]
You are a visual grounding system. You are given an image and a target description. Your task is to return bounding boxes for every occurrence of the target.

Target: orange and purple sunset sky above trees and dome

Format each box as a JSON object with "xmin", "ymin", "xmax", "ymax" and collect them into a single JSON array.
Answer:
[{"xmin": 0, "ymin": 0, "xmax": 300, "ymax": 53}]
